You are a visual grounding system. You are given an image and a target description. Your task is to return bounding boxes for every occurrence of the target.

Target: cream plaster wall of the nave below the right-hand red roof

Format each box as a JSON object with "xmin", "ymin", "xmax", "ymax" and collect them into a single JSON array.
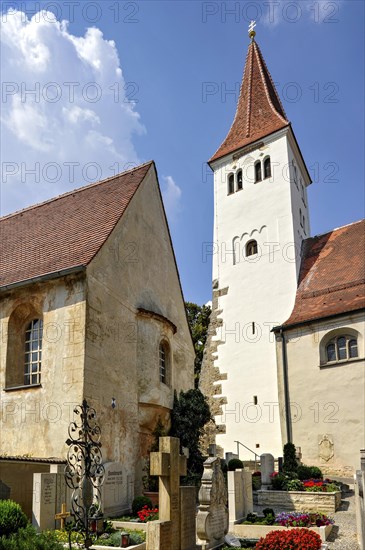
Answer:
[{"xmin": 277, "ymin": 313, "xmax": 365, "ymax": 470}]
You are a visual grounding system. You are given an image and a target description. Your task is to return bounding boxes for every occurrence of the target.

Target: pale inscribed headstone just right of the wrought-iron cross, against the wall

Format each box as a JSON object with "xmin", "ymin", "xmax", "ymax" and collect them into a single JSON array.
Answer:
[{"xmin": 100, "ymin": 462, "xmax": 131, "ymax": 517}]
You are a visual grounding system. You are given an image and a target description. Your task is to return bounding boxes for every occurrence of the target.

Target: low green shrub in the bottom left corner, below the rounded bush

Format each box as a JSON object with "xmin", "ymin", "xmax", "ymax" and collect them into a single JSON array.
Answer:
[{"xmin": 0, "ymin": 525, "xmax": 64, "ymax": 550}]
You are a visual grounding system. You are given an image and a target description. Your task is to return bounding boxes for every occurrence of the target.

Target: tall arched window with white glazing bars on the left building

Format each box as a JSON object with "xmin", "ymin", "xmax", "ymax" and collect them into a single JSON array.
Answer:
[{"xmin": 24, "ymin": 319, "xmax": 43, "ymax": 386}]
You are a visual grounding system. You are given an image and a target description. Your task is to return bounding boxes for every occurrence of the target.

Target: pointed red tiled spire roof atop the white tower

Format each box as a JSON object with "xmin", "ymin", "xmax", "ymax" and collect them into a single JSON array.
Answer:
[{"xmin": 209, "ymin": 40, "xmax": 289, "ymax": 162}]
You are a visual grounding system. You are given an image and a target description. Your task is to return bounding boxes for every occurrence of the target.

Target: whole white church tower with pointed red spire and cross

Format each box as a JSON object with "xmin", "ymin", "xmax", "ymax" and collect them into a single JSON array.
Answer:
[{"xmin": 201, "ymin": 24, "xmax": 311, "ymax": 459}]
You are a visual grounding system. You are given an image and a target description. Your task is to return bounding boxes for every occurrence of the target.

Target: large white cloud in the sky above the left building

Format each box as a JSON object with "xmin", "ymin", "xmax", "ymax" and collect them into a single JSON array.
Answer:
[{"xmin": 1, "ymin": 10, "xmax": 145, "ymax": 214}]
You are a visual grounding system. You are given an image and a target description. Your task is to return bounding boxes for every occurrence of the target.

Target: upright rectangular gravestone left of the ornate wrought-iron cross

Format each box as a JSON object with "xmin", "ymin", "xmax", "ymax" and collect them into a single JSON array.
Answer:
[{"xmin": 32, "ymin": 473, "xmax": 58, "ymax": 531}]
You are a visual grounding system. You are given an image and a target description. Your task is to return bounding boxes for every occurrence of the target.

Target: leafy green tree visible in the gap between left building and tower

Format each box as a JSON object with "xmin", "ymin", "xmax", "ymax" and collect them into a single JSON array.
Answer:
[{"xmin": 185, "ymin": 302, "xmax": 212, "ymax": 388}]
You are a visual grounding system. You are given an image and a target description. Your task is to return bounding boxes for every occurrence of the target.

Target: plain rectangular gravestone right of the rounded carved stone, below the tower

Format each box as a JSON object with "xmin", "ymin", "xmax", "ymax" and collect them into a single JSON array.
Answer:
[{"xmin": 227, "ymin": 470, "xmax": 253, "ymax": 525}]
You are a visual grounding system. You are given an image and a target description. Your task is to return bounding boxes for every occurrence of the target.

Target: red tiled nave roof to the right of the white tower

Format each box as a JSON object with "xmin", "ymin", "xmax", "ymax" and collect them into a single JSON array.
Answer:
[{"xmin": 284, "ymin": 220, "xmax": 365, "ymax": 327}]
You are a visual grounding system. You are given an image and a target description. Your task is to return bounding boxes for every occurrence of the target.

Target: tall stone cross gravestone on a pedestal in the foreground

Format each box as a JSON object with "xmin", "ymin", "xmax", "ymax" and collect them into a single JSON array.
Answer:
[{"xmin": 146, "ymin": 437, "xmax": 196, "ymax": 550}]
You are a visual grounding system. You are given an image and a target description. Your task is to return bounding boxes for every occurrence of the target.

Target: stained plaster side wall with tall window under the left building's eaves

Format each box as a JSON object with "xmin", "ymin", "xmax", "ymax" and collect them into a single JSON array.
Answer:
[{"xmin": 0, "ymin": 276, "xmax": 85, "ymax": 458}]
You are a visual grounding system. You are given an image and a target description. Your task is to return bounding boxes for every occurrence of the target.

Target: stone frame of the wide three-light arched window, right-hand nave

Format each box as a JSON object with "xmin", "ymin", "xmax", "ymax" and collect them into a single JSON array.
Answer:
[{"xmin": 319, "ymin": 327, "xmax": 363, "ymax": 367}]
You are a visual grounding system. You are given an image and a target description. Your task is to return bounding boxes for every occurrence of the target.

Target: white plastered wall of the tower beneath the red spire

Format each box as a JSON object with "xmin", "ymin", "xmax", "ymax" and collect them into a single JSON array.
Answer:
[{"xmin": 211, "ymin": 126, "xmax": 310, "ymax": 459}]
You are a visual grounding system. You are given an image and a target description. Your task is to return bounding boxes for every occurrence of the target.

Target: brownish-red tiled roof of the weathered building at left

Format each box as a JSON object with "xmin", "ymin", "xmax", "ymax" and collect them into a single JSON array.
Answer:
[{"xmin": 0, "ymin": 162, "xmax": 153, "ymax": 287}]
